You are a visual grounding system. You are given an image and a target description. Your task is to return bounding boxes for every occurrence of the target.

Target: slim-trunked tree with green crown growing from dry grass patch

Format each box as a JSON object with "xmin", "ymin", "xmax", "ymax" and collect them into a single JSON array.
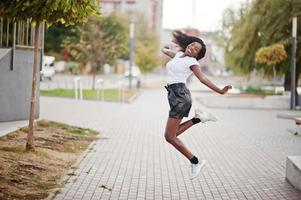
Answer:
[{"xmin": 0, "ymin": 0, "xmax": 98, "ymax": 150}]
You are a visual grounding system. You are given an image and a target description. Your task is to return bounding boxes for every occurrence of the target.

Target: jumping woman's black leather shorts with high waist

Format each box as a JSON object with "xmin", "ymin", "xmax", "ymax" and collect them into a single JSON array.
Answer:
[{"xmin": 165, "ymin": 83, "xmax": 192, "ymax": 119}]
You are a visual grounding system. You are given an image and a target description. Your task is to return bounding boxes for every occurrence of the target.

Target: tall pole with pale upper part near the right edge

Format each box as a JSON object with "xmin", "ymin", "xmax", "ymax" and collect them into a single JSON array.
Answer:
[{"xmin": 290, "ymin": 17, "xmax": 297, "ymax": 110}]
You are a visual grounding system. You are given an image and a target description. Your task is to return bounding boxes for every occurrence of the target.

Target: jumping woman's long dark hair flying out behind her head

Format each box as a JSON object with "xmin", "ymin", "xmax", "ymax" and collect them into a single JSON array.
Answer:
[{"xmin": 172, "ymin": 30, "xmax": 206, "ymax": 60}]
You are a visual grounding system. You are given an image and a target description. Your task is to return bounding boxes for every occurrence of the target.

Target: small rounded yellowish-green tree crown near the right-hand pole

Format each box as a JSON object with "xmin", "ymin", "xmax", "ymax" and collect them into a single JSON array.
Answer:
[{"xmin": 255, "ymin": 44, "xmax": 287, "ymax": 65}]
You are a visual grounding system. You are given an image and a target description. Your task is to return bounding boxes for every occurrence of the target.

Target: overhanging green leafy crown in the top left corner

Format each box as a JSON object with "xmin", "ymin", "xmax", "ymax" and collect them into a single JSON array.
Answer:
[{"xmin": 0, "ymin": 0, "xmax": 98, "ymax": 24}]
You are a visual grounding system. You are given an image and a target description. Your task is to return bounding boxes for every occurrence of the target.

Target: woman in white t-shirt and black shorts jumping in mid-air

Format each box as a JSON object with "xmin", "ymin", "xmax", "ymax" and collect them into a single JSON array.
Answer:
[{"xmin": 162, "ymin": 31, "xmax": 232, "ymax": 179}]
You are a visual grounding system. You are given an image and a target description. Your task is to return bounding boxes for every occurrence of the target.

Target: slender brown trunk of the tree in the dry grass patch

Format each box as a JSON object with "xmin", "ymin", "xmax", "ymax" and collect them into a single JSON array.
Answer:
[{"xmin": 26, "ymin": 21, "xmax": 41, "ymax": 150}]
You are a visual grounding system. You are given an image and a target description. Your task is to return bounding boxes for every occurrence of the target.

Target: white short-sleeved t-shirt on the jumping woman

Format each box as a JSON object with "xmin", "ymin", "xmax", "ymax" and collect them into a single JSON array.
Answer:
[{"xmin": 166, "ymin": 51, "xmax": 200, "ymax": 85}]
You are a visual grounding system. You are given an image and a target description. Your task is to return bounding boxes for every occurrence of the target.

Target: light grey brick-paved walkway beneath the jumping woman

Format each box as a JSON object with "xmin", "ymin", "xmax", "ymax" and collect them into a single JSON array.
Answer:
[{"xmin": 41, "ymin": 89, "xmax": 301, "ymax": 200}]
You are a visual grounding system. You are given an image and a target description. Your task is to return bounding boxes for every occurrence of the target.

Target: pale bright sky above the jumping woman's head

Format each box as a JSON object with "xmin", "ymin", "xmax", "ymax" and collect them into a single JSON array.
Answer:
[{"xmin": 163, "ymin": 0, "xmax": 246, "ymax": 31}]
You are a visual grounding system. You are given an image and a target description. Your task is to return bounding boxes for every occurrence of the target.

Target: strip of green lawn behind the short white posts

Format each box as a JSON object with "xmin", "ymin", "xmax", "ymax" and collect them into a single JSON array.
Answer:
[{"xmin": 40, "ymin": 89, "xmax": 136, "ymax": 101}]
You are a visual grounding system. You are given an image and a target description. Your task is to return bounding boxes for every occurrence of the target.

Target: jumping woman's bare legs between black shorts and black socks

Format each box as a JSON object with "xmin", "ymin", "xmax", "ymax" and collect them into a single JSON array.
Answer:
[{"xmin": 165, "ymin": 117, "xmax": 194, "ymax": 160}]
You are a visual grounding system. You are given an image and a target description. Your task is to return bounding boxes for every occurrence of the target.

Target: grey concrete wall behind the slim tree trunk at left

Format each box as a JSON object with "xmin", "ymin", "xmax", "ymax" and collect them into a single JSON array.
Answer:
[{"xmin": 0, "ymin": 49, "xmax": 40, "ymax": 122}]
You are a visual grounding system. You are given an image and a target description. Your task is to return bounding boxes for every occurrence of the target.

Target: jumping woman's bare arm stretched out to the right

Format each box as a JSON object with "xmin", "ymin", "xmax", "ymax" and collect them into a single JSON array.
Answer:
[{"xmin": 190, "ymin": 65, "xmax": 232, "ymax": 94}]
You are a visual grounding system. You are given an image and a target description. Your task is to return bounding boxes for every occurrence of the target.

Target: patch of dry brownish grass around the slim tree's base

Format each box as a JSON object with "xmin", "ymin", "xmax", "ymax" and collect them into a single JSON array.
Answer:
[{"xmin": 0, "ymin": 120, "xmax": 97, "ymax": 199}]
